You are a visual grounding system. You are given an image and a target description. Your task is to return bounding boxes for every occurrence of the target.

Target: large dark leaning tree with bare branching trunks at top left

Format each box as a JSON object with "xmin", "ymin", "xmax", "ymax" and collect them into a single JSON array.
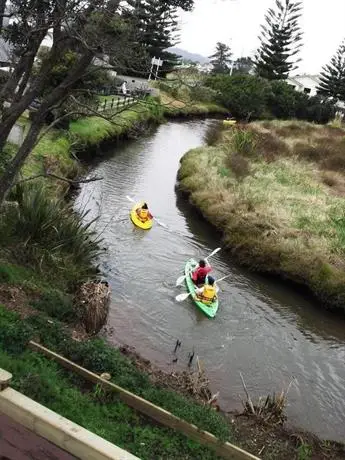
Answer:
[{"xmin": 0, "ymin": 0, "xmax": 191, "ymax": 205}]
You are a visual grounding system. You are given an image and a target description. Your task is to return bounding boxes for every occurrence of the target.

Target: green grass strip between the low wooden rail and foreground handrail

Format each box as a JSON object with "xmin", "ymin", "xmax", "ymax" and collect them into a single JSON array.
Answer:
[{"xmin": 0, "ymin": 351, "xmax": 222, "ymax": 460}]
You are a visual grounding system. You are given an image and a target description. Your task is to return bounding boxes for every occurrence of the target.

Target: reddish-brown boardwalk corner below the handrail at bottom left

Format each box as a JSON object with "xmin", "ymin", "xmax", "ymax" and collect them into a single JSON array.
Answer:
[{"xmin": 0, "ymin": 413, "xmax": 76, "ymax": 460}]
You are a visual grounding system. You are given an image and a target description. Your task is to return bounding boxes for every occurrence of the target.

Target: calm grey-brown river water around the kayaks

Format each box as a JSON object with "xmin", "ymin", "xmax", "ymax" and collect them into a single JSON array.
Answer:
[{"xmin": 76, "ymin": 121, "xmax": 345, "ymax": 441}]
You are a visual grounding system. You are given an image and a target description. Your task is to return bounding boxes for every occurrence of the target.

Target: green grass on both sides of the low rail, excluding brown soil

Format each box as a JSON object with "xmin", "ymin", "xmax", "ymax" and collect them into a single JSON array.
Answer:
[{"xmin": 0, "ymin": 306, "xmax": 232, "ymax": 459}]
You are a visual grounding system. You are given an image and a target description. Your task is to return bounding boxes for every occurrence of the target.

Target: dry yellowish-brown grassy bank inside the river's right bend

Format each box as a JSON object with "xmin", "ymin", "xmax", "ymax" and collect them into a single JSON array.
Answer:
[{"xmin": 179, "ymin": 121, "xmax": 345, "ymax": 312}]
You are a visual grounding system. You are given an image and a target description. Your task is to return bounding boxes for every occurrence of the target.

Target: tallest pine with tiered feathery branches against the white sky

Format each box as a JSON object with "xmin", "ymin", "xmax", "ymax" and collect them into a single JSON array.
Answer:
[{"xmin": 255, "ymin": 0, "xmax": 303, "ymax": 80}]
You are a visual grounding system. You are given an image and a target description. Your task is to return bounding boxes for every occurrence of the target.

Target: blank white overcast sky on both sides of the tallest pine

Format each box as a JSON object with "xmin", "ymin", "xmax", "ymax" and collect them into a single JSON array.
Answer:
[{"xmin": 177, "ymin": 0, "xmax": 345, "ymax": 73}]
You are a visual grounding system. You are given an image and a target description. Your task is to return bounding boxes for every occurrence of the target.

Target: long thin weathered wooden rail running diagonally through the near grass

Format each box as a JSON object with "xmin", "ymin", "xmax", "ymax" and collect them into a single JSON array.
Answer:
[{"xmin": 29, "ymin": 341, "xmax": 259, "ymax": 460}]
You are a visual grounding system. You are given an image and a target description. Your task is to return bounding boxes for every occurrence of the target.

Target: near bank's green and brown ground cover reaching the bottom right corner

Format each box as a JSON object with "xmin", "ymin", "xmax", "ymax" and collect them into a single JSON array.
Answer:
[{"xmin": 0, "ymin": 306, "xmax": 345, "ymax": 460}]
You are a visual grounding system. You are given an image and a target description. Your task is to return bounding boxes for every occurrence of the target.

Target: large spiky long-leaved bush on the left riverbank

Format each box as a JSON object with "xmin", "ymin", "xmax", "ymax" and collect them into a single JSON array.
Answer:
[{"xmin": 2, "ymin": 183, "xmax": 100, "ymax": 280}]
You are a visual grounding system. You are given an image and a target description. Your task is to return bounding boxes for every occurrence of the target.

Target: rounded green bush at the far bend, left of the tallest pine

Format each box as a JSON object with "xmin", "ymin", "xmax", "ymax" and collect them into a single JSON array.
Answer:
[{"xmin": 206, "ymin": 75, "xmax": 270, "ymax": 120}]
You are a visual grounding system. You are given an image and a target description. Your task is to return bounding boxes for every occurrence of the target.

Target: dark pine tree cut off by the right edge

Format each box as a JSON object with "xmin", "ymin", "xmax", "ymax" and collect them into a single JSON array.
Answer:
[{"xmin": 317, "ymin": 42, "xmax": 345, "ymax": 101}]
